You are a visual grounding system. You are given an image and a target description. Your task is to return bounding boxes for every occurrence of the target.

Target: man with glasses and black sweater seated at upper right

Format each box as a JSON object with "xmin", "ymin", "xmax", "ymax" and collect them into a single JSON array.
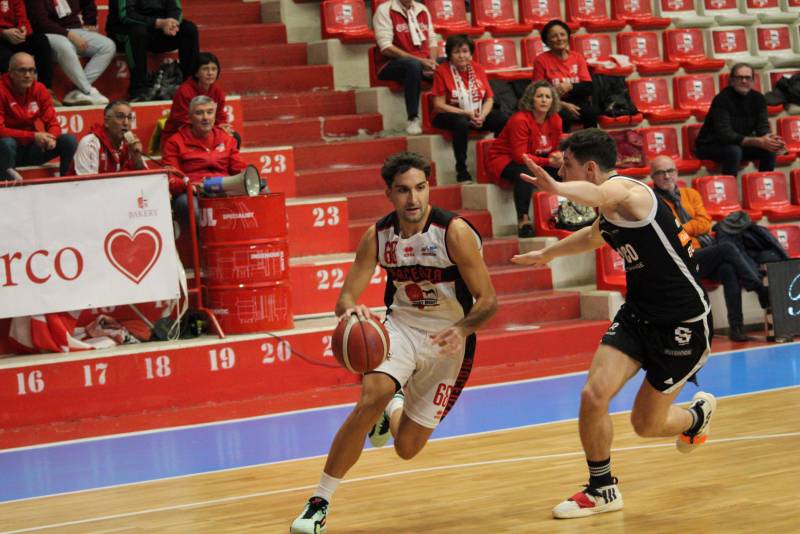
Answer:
[{"xmin": 694, "ymin": 63, "xmax": 785, "ymax": 176}]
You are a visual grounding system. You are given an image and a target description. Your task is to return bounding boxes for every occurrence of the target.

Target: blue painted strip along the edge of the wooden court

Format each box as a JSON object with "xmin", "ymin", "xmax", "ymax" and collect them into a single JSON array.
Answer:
[{"xmin": 0, "ymin": 343, "xmax": 800, "ymax": 502}]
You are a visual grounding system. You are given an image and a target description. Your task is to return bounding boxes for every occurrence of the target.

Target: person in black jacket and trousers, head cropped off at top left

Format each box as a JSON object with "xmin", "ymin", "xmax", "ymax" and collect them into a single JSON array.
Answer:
[{"xmin": 106, "ymin": 0, "xmax": 200, "ymax": 102}]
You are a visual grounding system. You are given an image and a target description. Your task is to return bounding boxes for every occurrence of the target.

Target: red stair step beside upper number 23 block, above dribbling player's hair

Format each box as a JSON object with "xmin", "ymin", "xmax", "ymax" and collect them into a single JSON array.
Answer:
[{"xmin": 294, "ymin": 137, "xmax": 406, "ymax": 171}]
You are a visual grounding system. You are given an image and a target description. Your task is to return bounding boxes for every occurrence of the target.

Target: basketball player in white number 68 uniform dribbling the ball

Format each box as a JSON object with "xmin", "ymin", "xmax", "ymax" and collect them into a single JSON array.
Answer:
[{"xmin": 290, "ymin": 152, "xmax": 497, "ymax": 534}]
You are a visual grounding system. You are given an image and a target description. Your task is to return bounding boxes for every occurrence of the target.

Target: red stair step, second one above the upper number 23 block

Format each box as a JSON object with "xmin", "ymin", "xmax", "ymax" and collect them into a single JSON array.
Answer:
[{"xmin": 242, "ymin": 91, "xmax": 356, "ymax": 120}]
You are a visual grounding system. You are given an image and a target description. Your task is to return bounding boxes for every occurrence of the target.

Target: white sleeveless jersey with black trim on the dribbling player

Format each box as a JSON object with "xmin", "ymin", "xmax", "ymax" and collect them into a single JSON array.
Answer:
[{"xmin": 375, "ymin": 208, "xmax": 481, "ymax": 332}]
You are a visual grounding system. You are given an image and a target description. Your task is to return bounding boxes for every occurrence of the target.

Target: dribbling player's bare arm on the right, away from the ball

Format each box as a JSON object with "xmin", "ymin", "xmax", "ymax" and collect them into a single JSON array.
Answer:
[{"xmin": 432, "ymin": 219, "xmax": 497, "ymax": 354}]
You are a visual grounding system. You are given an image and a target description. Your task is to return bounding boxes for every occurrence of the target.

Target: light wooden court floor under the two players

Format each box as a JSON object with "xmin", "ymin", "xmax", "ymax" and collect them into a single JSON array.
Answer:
[{"xmin": 0, "ymin": 387, "xmax": 800, "ymax": 534}]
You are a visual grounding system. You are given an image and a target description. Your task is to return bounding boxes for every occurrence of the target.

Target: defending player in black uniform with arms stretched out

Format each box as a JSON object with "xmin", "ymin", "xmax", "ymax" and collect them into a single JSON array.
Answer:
[{"xmin": 512, "ymin": 128, "xmax": 716, "ymax": 519}]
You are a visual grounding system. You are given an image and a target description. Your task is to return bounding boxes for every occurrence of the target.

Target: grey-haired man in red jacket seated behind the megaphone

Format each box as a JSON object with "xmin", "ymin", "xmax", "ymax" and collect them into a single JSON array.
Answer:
[{"xmin": 161, "ymin": 95, "xmax": 247, "ymax": 219}]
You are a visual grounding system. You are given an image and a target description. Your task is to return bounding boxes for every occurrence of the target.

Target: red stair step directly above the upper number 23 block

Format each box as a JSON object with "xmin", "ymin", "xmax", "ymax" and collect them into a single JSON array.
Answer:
[{"xmin": 243, "ymin": 113, "xmax": 383, "ymax": 146}]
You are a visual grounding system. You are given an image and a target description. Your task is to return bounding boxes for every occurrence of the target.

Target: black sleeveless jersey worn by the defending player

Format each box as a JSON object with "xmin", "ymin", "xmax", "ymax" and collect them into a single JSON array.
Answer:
[{"xmin": 600, "ymin": 176, "xmax": 710, "ymax": 324}]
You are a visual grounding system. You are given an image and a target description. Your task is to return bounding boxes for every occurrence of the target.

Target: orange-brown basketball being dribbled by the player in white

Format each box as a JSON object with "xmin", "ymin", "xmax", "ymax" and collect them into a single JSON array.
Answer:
[{"xmin": 331, "ymin": 314, "xmax": 389, "ymax": 374}]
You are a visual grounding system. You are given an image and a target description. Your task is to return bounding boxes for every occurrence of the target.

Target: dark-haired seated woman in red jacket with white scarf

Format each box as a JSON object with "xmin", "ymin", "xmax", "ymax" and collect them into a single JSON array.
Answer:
[{"xmin": 433, "ymin": 35, "xmax": 506, "ymax": 183}]
